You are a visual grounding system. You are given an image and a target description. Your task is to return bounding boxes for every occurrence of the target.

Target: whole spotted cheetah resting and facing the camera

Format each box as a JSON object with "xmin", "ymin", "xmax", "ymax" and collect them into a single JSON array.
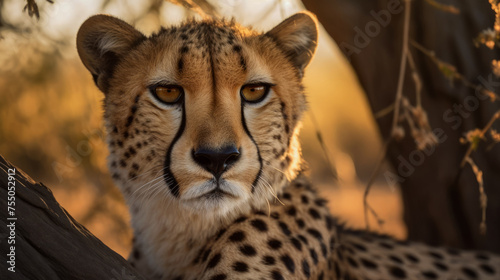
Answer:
[{"xmin": 77, "ymin": 12, "xmax": 500, "ymax": 280}]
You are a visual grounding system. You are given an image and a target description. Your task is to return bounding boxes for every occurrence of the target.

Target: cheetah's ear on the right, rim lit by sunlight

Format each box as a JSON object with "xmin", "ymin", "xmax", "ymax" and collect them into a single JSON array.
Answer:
[{"xmin": 266, "ymin": 12, "xmax": 318, "ymax": 75}]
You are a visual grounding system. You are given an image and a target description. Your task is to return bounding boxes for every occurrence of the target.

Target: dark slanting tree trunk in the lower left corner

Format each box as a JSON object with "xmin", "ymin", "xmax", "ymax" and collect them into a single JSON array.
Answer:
[{"xmin": 0, "ymin": 156, "xmax": 144, "ymax": 280}]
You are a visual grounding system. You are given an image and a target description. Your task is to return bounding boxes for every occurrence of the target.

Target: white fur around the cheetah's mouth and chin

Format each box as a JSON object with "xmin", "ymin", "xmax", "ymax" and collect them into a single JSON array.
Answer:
[{"xmin": 180, "ymin": 179, "xmax": 249, "ymax": 216}]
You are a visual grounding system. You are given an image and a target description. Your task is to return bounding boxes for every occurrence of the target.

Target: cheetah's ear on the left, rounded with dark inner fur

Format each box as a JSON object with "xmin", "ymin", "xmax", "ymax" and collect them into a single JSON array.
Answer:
[{"xmin": 76, "ymin": 15, "xmax": 146, "ymax": 93}]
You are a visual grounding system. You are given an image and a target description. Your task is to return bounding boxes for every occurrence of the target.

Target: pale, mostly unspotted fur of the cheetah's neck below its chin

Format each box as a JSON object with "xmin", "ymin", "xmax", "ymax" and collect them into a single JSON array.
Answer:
[{"xmin": 129, "ymin": 190, "xmax": 267, "ymax": 279}]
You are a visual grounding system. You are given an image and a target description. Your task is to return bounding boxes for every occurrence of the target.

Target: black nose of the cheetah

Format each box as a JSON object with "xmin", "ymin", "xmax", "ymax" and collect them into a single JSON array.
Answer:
[{"xmin": 192, "ymin": 145, "xmax": 240, "ymax": 180}]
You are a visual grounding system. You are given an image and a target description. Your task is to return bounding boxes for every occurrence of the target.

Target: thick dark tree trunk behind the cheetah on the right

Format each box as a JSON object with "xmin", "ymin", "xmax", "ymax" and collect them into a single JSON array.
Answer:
[{"xmin": 303, "ymin": 0, "xmax": 500, "ymax": 252}]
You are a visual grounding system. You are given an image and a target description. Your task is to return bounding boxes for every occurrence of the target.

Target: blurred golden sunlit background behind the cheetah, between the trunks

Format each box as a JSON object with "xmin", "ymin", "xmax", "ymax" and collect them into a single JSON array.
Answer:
[{"xmin": 0, "ymin": 0, "xmax": 406, "ymax": 257}]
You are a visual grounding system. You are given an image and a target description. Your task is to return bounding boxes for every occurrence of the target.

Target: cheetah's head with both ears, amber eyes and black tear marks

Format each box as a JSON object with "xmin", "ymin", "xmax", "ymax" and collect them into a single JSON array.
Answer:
[{"xmin": 77, "ymin": 13, "xmax": 317, "ymax": 217}]
